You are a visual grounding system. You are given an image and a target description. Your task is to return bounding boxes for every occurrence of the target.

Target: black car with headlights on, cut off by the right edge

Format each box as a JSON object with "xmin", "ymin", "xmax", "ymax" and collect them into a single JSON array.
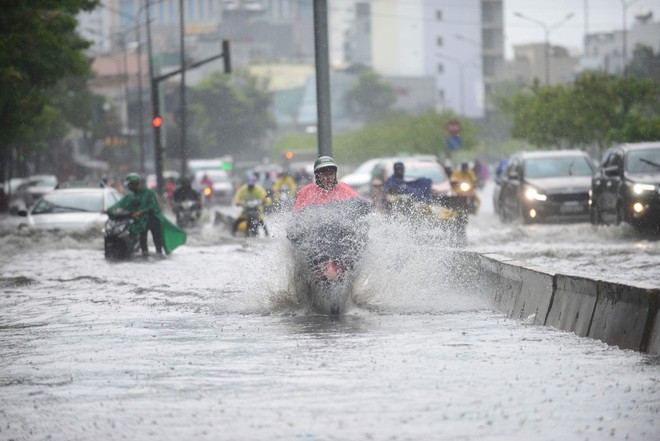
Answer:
[{"xmin": 590, "ymin": 142, "xmax": 660, "ymax": 231}]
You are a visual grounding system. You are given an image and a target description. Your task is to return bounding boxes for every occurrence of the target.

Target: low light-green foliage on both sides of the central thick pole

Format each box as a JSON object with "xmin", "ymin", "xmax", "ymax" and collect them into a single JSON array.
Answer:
[{"xmin": 274, "ymin": 112, "xmax": 478, "ymax": 165}]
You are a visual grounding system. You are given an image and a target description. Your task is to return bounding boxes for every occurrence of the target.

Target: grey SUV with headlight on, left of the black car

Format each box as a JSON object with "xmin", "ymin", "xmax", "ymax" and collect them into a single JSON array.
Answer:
[{"xmin": 493, "ymin": 150, "xmax": 594, "ymax": 223}]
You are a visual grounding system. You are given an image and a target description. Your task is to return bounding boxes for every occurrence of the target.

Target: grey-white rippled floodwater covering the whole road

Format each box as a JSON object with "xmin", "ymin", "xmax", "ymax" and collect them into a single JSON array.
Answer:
[{"xmin": 0, "ymin": 186, "xmax": 660, "ymax": 440}]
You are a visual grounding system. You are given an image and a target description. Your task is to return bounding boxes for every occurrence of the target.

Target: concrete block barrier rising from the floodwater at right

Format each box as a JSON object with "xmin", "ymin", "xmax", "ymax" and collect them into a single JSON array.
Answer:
[{"xmin": 479, "ymin": 254, "xmax": 660, "ymax": 355}]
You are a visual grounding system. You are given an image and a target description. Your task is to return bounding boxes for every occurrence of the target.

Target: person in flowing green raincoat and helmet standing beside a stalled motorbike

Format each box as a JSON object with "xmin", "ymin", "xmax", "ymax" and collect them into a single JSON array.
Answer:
[{"xmin": 108, "ymin": 173, "xmax": 186, "ymax": 255}]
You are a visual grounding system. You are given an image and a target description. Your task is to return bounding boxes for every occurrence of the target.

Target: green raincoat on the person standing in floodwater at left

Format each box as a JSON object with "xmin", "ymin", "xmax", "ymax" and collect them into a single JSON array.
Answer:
[{"xmin": 108, "ymin": 187, "xmax": 186, "ymax": 254}]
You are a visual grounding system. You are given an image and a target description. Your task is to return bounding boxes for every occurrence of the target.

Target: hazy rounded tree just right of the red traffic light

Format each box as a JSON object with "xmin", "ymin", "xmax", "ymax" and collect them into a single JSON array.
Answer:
[{"xmin": 189, "ymin": 71, "xmax": 275, "ymax": 157}]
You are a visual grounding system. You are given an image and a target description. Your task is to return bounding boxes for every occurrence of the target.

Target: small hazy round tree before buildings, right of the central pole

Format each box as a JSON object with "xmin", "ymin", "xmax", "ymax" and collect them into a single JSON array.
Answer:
[{"xmin": 348, "ymin": 70, "xmax": 396, "ymax": 122}]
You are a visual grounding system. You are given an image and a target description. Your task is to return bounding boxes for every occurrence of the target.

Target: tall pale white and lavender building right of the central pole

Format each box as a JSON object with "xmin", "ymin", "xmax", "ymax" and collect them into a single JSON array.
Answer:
[{"xmin": 342, "ymin": 0, "xmax": 504, "ymax": 118}]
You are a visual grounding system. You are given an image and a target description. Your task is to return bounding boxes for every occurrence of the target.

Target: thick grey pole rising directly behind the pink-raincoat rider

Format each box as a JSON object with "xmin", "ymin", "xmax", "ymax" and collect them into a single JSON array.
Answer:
[{"xmin": 313, "ymin": 0, "xmax": 332, "ymax": 156}]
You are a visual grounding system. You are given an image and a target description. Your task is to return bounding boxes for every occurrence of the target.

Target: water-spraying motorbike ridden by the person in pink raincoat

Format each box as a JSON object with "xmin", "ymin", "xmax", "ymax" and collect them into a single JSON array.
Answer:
[{"xmin": 287, "ymin": 198, "xmax": 371, "ymax": 316}]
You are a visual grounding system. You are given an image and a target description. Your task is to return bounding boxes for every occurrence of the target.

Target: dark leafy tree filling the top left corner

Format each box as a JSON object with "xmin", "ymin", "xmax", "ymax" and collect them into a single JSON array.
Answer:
[{"xmin": 0, "ymin": 0, "xmax": 98, "ymax": 179}]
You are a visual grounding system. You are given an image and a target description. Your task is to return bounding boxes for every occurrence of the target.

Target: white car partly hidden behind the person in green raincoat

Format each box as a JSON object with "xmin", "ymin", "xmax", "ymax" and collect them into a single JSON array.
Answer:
[{"xmin": 19, "ymin": 187, "xmax": 122, "ymax": 232}]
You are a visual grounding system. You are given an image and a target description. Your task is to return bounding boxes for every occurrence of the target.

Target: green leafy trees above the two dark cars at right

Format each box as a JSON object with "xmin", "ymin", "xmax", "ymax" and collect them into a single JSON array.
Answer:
[{"xmin": 500, "ymin": 73, "xmax": 660, "ymax": 152}]
